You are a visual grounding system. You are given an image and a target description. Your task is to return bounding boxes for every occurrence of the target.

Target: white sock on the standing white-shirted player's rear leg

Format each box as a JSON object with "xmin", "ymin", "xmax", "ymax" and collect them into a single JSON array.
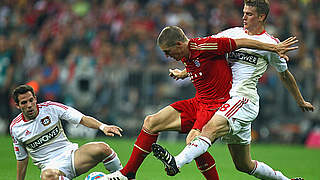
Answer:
[{"xmin": 250, "ymin": 161, "xmax": 290, "ymax": 180}]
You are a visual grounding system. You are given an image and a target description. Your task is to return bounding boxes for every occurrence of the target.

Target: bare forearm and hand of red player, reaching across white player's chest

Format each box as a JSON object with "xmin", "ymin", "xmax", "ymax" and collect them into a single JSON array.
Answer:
[{"xmin": 234, "ymin": 37, "xmax": 298, "ymax": 61}]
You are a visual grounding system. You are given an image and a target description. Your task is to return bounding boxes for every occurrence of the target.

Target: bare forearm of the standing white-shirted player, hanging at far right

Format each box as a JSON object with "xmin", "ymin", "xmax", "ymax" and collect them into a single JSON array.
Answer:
[{"xmin": 280, "ymin": 70, "xmax": 304, "ymax": 105}]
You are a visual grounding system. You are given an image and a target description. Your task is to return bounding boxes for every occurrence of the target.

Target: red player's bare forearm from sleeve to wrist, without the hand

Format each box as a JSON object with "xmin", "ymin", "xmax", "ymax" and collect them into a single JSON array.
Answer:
[{"xmin": 235, "ymin": 38, "xmax": 276, "ymax": 52}]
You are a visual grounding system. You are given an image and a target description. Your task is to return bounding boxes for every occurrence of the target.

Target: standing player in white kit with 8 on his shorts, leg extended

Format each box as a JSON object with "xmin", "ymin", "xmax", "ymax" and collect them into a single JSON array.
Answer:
[{"xmin": 152, "ymin": 0, "xmax": 314, "ymax": 180}]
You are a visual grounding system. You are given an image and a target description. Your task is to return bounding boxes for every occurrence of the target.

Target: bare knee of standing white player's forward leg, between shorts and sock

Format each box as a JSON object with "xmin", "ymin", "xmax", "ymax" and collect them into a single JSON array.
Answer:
[{"xmin": 201, "ymin": 114, "xmax": 230, "ymax": 141}]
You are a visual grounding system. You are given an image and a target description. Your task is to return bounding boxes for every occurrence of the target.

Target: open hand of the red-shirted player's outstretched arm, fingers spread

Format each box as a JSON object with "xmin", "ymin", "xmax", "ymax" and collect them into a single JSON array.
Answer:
[{"xmin": 276, "ymin": 37, "xmax": 298, "ymax": 61}]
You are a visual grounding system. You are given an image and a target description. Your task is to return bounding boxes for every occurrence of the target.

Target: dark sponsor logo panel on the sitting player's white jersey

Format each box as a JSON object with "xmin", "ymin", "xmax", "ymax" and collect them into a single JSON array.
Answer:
[{"xmin": 26, "ymin": 126, "xmax": 60, "ymax": 149}]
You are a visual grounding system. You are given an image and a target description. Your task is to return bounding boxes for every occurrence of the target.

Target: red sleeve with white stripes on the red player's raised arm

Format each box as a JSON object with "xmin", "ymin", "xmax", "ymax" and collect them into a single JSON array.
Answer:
[{"xmin": 190, "ymin": 36, "xmax": 237, "ymax": 55}]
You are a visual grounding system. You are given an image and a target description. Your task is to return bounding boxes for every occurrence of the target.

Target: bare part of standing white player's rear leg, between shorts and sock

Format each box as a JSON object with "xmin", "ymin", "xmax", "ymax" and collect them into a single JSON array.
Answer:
[{"xmin": 228, "ymin": 144, "xmax": 255, "ymax": 172}]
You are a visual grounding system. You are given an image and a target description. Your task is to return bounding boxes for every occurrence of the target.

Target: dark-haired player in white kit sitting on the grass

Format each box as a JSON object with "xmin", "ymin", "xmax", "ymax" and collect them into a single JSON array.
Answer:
[{"xmin": 10, "ymin": 85, "xmax": 122, "ymax": 180}]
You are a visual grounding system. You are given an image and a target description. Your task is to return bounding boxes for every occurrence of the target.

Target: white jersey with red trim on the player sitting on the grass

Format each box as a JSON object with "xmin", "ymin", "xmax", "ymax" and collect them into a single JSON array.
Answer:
[{"xmin": 10, "ymin": 101, "xmax": 84, "ymax": 168}]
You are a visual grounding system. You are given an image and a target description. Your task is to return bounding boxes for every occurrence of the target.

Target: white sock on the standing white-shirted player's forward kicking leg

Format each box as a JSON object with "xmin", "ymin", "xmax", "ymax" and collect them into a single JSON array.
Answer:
[{"xmin": 175, "ymin": 136, "xmax": 211, "ymax": 168}]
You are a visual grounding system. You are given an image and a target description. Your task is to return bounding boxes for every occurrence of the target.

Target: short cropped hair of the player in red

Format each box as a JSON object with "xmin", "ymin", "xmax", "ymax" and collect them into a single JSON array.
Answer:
[{"xmin": 157, "ymin": 26, "xmax": 188, "ymax": 47}]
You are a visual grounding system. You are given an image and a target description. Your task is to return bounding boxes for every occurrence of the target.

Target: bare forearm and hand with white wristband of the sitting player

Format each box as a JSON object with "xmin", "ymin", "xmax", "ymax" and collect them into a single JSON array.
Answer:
[{"xmin": 80, "ymin": 116, "xmax": 122, "ymax": 136}]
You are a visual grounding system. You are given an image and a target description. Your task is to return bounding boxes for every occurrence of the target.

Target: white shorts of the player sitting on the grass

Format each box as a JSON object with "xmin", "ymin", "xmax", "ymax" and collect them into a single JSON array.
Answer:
[{"xmin": 41, "ymin": 143, "xmax": 78, "ymax": 179}]
